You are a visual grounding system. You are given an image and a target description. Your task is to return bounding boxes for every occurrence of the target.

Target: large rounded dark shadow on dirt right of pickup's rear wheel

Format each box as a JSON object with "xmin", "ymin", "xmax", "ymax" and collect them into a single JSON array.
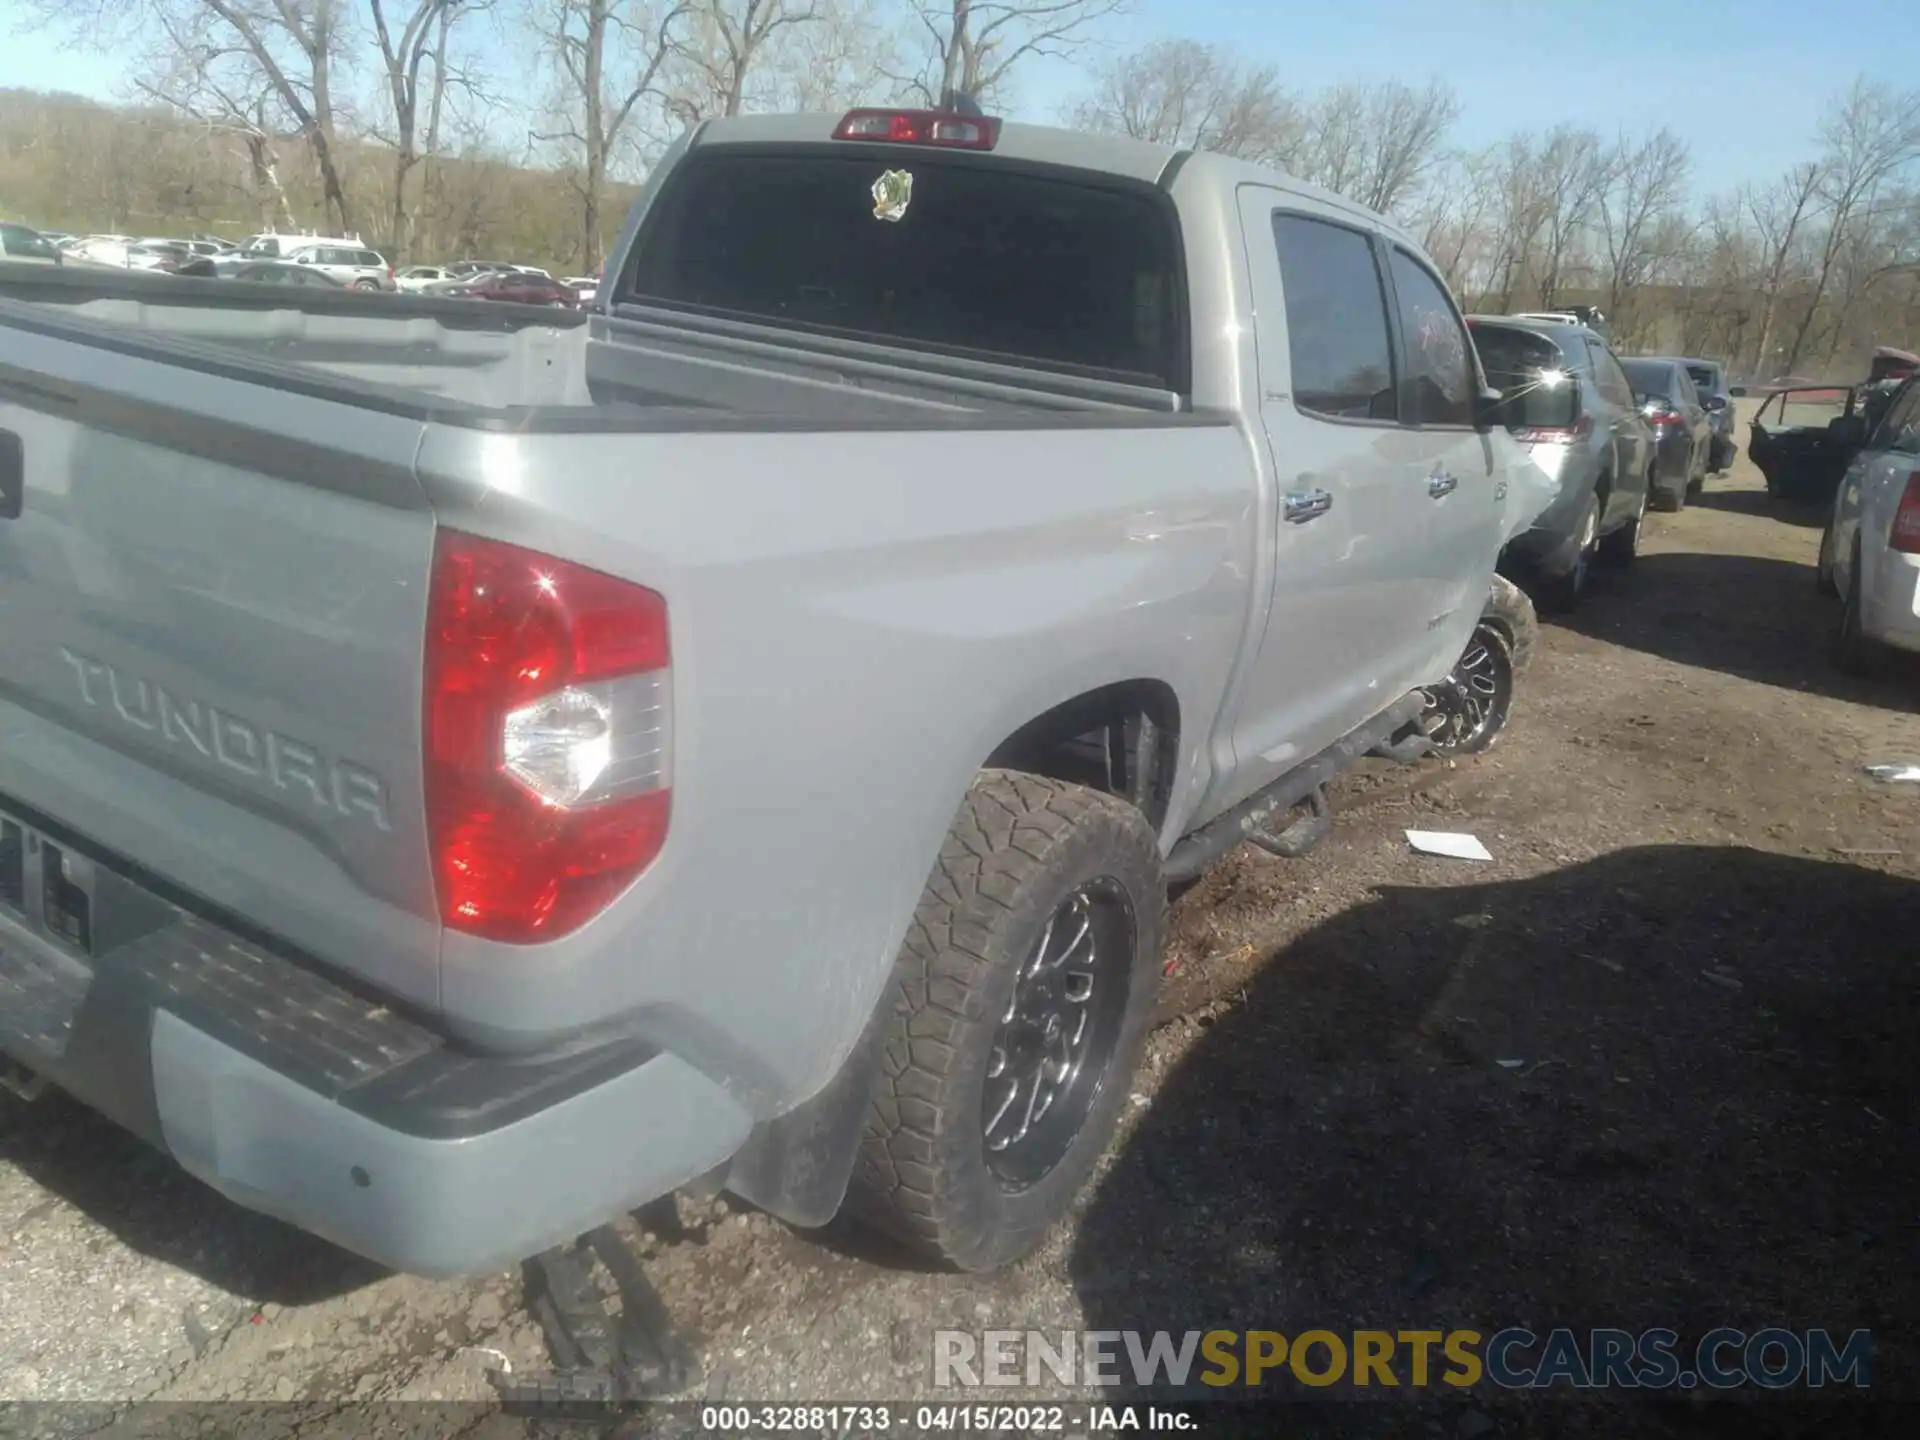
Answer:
[{"xmin": 1069, "ymin": 847, "xmax": 1920, "ymax": 1436}]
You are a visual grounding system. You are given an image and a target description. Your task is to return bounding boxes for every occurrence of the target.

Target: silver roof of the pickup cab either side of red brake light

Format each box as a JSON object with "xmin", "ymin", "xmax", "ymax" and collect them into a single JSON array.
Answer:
[{"xmin": 689, "ymin": 106, "xmax": 1425, "ymax": 253}]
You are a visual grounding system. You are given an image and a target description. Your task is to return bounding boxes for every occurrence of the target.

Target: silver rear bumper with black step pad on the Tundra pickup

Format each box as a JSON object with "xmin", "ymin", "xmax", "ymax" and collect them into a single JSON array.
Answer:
[{"xmin": 0, "ymin": 801, "xmax": 751, "ymax": 1275}]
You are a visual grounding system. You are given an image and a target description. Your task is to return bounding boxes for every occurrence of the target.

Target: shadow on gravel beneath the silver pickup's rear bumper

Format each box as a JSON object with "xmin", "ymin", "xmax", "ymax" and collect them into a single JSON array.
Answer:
[{"xmin": 0, "ymin": 1091, "xmax": 386, "ymax": 1306}]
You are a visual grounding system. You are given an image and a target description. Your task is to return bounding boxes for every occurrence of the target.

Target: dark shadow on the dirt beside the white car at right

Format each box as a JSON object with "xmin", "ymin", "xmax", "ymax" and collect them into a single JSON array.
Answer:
[{"xmin": 1548, "ymin": 551, "xmax": 1920, "ymax": 710}]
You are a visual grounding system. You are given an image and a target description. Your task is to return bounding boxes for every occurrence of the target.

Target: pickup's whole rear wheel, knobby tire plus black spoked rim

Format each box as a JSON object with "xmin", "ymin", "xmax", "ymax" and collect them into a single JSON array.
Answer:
[{"xmin": 847, "ymin": 770, "xmax": 1165, "ymax": 1271}]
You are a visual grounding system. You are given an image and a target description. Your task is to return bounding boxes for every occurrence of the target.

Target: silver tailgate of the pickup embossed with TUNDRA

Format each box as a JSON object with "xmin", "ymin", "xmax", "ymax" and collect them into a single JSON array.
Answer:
[{"xmin": 0, "ymin": 321, "xmax": 440, "ymax": 1006}]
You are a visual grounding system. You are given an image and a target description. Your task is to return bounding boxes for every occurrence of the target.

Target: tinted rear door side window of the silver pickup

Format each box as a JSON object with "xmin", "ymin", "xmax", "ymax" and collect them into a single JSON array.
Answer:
[{"xmin": 1273, "ymin": 211, "xmax": 1400, "ymax": 420}]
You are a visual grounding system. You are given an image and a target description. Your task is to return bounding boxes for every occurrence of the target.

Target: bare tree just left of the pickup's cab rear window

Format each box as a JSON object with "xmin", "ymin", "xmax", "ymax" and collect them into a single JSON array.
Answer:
[{"xmin": 536, "ymin": 0, "xmax": 689, "ymax": 275}]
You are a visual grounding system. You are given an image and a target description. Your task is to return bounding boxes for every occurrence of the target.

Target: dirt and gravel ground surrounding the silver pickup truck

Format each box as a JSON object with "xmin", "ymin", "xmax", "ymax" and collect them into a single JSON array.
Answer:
[{"xmin": 0, "ymin": 445, "xmax": 1920, "ymax": 1434}]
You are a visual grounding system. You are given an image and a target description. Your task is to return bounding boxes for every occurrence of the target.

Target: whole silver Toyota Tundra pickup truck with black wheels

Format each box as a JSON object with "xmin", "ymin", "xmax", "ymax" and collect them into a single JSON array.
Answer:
[{"xmin": 0, "ymin": 111, "xmax": 1530, "ymax": 1275}]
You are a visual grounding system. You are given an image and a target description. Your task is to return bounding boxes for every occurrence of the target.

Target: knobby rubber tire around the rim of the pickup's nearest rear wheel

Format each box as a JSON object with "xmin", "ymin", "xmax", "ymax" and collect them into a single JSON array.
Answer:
[{"xmin": 847, "ymin": 770, "xmax": 1165, "ymax": 1273}]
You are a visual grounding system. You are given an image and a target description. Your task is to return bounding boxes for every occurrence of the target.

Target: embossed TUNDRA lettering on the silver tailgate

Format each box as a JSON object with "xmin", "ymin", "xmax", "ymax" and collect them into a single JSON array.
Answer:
[{"xmin": 60, "ymin": 645, "xmax": 394, "ymax": 831}]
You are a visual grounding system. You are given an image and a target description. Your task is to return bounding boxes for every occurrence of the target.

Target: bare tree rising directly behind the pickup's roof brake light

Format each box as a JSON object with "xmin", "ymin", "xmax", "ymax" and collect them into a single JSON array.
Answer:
[{"xmin": 897, "ymin": 0, "xmax": 1127, "ymax": 106}]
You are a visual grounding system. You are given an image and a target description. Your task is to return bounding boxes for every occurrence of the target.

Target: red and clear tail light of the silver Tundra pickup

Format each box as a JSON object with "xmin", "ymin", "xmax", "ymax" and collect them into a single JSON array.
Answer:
[{"xmin": 424, "ymin": 530, "xmax": 672, "ymax": 945}]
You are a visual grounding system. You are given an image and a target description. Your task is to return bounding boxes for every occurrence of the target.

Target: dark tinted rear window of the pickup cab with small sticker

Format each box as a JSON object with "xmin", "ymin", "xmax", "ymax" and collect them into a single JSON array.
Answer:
[{"xmin": 616, "ymin": 146, "xmax": 1187, "ymax": 392}]
